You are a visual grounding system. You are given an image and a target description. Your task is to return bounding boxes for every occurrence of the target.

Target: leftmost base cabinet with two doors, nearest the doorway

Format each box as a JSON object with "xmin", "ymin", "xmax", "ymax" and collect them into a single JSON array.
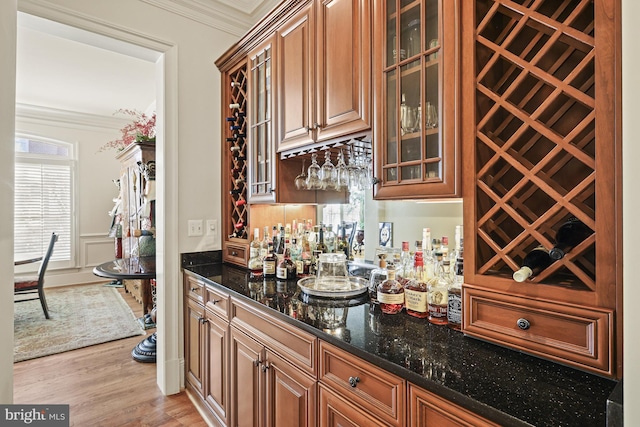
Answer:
[{"xmin": 184, "ymin": 274, "xmax": 230, "ymax": 426}]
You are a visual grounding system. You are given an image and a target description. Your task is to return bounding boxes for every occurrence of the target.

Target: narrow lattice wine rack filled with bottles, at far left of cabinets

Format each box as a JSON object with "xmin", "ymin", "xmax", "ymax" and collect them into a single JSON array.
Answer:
[{"xmin": 224, "ymin": 63, "xmax": 249, "ymax": 240}]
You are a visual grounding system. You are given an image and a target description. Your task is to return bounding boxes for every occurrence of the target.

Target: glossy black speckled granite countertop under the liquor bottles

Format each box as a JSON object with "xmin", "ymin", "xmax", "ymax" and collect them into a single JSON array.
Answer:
[{"xmin": 183, "ymin": 261, "xmax": 617, "ymax": 427}]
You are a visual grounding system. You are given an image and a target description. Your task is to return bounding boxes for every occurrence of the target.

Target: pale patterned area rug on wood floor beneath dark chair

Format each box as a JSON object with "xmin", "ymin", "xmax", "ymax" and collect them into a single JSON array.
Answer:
[{"xmin": 13, "ymin": 283, "xmax": 145, "ymax": 362}]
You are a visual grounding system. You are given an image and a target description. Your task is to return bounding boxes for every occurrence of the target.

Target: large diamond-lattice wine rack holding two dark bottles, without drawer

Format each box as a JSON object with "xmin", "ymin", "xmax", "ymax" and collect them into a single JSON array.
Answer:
[{"xmin": 473, "ymin": 0, "xmax": 600, "ymax": 291}]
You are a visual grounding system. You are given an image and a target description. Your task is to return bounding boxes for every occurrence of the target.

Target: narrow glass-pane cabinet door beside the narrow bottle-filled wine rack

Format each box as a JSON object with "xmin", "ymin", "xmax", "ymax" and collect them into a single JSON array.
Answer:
[{"xmin": 247, "ymin": 39, "xmax": 276, "ymax": 203}]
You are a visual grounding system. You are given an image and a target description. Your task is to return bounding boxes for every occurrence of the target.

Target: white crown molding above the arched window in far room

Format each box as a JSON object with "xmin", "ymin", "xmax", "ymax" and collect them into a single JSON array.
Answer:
[{"xmin": 16, "ymin": 103, "xmax": 130, "ymax": 130}]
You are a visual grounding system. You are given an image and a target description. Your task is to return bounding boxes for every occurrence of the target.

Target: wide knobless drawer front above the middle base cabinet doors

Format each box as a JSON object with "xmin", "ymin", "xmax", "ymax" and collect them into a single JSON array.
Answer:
[{"xmin": 231, "ymin": 298, "xmax": 318, "ymax": 378}]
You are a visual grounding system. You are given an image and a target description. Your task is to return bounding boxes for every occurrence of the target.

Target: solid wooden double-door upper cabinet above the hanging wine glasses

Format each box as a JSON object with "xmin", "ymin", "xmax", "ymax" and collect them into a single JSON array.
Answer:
[{"xmin": 275, "ymin": 0, "xmax": 371, "ymax": 152}]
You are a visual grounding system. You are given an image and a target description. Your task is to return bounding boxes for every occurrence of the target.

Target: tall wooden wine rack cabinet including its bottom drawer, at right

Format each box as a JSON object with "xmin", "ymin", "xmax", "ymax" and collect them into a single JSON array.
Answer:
[{"xmin": 461, "ymin": 0, "xmax": 622, "ymax": 376}]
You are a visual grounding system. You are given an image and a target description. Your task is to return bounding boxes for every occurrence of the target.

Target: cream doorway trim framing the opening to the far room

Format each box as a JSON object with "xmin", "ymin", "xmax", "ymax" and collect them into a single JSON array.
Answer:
[{"xmin": 18, "ymin": 0, "xmax": 183, "ymax": 395}]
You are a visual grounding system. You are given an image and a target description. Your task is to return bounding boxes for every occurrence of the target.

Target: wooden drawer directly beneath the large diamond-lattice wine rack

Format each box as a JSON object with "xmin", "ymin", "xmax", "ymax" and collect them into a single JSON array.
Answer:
[{"xmin": 463, "ymin": 287, "xmax": 613, "ymax": 374}]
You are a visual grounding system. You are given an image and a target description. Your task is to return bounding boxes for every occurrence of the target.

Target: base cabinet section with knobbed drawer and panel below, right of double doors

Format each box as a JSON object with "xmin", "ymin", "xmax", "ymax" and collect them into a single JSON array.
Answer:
[{"xmin": 319, "ymin": 341, "xmax": 406, "ymax": 426}]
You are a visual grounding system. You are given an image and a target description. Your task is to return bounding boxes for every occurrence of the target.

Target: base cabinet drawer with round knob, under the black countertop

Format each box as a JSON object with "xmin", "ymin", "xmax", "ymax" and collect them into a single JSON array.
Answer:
[{"xmin": 319, "ymin": 341, "xmax": 406, "ymax": 425}]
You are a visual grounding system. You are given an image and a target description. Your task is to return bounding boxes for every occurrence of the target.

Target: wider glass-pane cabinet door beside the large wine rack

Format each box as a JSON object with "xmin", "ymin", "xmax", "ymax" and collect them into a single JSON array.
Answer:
[{"xmin": 374, "ymin": 0, "xmax": 460, "ymax": 199}]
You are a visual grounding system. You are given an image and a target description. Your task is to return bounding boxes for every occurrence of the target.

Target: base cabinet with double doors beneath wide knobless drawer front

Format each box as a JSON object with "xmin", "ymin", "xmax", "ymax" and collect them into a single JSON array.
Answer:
[{"xmin": 231, "ymin": 301, "xmax": 317, "ymax": 427}]
